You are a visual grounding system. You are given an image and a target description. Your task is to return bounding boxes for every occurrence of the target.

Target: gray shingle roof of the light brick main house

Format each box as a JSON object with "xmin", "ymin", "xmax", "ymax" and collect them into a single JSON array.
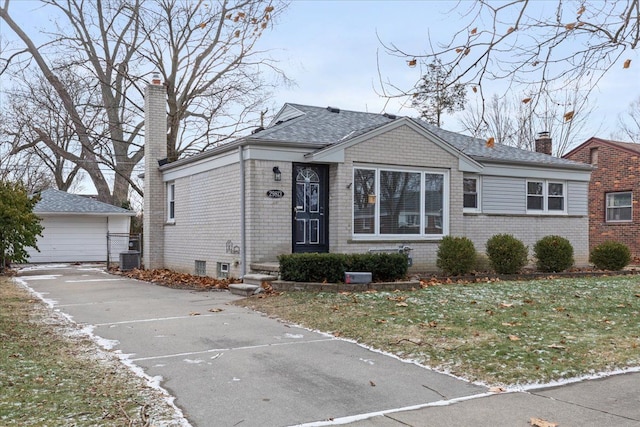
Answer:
[{"xmin": 251, "ymin": 103, "xmax": 591, "ymax": 170}]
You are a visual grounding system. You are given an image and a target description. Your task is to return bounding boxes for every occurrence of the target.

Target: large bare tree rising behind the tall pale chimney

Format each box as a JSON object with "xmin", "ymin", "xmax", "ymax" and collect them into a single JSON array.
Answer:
[{"xmin": 0, "ymin": 0, "xmax": 284, "ymax": 205}]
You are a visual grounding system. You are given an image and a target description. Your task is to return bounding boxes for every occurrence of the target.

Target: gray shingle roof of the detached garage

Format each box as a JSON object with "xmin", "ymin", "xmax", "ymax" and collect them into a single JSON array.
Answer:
[{"xmin": 33, "ymin": 189, "xmax": 135, "ymax": 216}]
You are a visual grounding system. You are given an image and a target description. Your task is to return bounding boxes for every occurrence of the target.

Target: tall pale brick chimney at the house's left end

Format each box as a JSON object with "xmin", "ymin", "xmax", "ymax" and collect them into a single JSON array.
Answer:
[{"xmin": 143, "ymin": 73, "xmax": 167, "ymax": 269}]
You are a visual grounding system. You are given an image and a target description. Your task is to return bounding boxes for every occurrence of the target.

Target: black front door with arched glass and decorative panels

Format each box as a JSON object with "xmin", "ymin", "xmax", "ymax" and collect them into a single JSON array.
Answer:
[{"xmin": 293, "ymin": 164, "xmax": 329, "ymax": 253}]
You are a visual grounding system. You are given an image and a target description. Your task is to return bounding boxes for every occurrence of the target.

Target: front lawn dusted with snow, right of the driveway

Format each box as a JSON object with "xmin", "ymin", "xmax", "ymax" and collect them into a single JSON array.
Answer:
[{"xmin": 240, "ymin": 276, "xmax": 640, "ymax": 385}]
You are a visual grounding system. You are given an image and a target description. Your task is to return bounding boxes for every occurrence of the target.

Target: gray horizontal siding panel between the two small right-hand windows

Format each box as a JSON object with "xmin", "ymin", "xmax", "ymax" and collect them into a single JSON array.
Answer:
[{"xmin": 481, "ymin": 176, "xmax": 527, "ymax": 214}]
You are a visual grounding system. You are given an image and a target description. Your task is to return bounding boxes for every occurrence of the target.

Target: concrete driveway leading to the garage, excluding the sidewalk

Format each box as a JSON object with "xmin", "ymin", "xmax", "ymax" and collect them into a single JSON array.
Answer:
[{"xmin": 13, "ymin": 265, "xmax": 487, "ymax": 427}]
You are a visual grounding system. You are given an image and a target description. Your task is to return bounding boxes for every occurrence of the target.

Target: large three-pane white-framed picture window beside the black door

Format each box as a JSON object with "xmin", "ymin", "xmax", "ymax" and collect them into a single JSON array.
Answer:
[{"xmin": 352, "ymin": 167, "xmax": 449, "ymax": 239}]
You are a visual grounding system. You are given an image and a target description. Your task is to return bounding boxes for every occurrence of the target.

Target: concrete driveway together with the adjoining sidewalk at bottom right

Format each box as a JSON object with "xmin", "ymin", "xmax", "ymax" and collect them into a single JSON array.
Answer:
[{"xmin": 13, "ymin": 265, "xmax": 640, "ymax": 427}]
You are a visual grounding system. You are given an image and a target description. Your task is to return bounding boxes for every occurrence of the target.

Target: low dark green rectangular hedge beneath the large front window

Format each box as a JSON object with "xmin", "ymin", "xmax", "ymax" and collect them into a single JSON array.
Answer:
[{"xmin": 278, "ymin": 253, "xmax": 409, "ymax": 283}]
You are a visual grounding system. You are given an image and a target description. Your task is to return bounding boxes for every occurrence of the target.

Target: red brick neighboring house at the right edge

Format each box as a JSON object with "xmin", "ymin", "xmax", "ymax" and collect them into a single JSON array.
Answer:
[{"xmin": 563, "ymin": 137, "xmax": 640, "ymax": 259}]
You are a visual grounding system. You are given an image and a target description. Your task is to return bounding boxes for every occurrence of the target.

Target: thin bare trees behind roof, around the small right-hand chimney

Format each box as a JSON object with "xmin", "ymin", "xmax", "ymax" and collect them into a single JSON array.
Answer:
[{"xmin": 460, "ymin": 84, "xmax": 593, "ymax": 156}]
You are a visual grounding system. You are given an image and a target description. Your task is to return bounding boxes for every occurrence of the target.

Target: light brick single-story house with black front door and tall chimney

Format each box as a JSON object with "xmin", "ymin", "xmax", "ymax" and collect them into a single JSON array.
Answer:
[{"xmin": 144, "ymin": 85, "xmax": 592, "ymax": 277}]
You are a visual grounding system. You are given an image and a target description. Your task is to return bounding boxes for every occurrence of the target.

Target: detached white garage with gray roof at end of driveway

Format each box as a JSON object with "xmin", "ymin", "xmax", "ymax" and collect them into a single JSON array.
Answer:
[{"xmin": 29, "ymin": 189, "xmax": 135, "ymax": 263}]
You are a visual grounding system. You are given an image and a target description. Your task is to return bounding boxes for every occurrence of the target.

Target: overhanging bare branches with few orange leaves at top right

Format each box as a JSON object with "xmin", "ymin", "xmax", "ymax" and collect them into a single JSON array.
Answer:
[{"xmin": 381, "ymin": 0, "xmax": 640, "ymax": 127}]
